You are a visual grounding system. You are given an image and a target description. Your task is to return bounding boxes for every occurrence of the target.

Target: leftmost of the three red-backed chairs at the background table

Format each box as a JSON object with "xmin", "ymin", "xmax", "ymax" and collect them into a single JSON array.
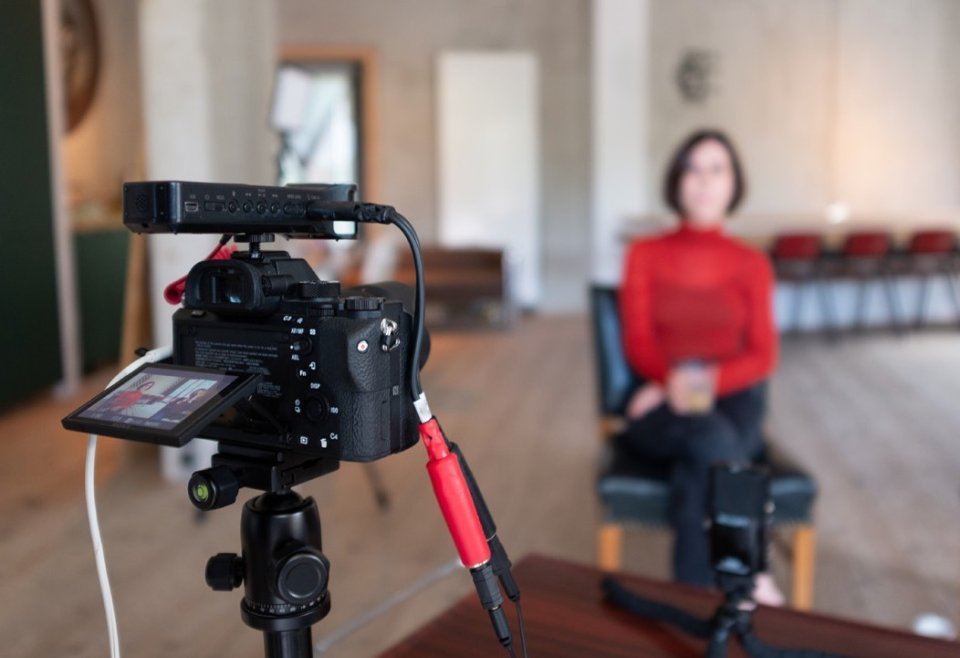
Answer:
[{"xmin": 770, "ymin": 233, "xmax": 834, "ymax": 331}]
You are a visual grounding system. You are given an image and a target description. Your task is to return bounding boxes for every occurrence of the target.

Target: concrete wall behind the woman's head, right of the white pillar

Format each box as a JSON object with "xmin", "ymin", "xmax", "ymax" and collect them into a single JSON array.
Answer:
[{"xmin": 650, "ymin": 0, "xmax": 960, "ymax": 221}]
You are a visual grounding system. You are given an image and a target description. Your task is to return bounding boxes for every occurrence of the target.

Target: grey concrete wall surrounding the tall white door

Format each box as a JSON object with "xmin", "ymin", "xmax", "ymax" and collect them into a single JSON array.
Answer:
[{"xmin": 277, "ymin": 0, "xmax": 590, "ymax": 310}]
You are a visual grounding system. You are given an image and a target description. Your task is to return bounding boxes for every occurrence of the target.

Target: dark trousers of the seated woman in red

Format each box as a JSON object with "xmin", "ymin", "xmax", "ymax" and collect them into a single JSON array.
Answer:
[{"xmin": 616, "ymin": 387, "xmax": 763, "ymax": 585}]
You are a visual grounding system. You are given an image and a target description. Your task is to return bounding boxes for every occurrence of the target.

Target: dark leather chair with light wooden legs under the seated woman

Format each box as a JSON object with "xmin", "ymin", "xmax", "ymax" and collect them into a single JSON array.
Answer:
[{"xmin": 590, "ymin": 286, "xmax": 817, "ymax": 610}]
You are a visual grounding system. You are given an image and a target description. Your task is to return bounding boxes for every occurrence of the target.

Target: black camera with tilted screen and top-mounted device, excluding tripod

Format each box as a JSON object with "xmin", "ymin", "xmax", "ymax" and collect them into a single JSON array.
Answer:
[{"xmin": 64, "ymin": 181, "xmax": 425, "ymax": 502}]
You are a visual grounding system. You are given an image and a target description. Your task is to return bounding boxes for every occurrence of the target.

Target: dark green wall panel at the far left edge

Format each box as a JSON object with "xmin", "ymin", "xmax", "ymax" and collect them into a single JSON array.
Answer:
[{"xmin": 0, "ymin": 0, "xmax": 61, "ymax": 407}]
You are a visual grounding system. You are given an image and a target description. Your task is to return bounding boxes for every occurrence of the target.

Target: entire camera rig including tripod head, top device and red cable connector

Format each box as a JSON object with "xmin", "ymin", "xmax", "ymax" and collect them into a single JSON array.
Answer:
[{"xmin": 63, "ymin": 181, "xmax": 523, "ymax": 658}]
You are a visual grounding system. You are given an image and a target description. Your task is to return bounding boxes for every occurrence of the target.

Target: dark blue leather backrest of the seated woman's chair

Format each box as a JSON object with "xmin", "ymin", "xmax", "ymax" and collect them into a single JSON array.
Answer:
[{"xmin": 590, "ymin": 285, "xmax": 641, "ymax": 416}]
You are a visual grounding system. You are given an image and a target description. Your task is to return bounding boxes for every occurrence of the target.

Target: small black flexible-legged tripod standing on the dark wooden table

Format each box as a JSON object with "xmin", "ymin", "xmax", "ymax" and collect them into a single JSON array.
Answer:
[{"xmin": 601, "ymin": 575, "xmax": 843, "ymax": 658}]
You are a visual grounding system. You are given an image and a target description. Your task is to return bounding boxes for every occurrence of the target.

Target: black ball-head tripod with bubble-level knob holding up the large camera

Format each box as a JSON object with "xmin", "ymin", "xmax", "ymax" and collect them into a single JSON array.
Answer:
[{"xmin": 188, "ymin": 446, "xmax": 336, "ymax": 658}]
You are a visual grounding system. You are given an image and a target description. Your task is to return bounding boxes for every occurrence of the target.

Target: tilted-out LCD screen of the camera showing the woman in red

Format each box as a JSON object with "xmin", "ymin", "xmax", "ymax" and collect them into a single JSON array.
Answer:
[{"xmin": 63, "ymin": 364, "xmax": 258, "ymax": 446}]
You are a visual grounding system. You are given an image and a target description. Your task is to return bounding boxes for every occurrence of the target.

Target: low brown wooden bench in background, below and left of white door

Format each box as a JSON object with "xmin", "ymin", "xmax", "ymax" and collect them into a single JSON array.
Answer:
[{"xmin": 395, "ymin": 247, "xmax": 515, "ymax": 328}]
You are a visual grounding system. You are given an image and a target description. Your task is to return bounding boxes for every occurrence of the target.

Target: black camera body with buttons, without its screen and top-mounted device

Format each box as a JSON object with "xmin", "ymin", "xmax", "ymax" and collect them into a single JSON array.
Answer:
[{"xmin": 173, "ymin": 251, "xmax": 419, "ymax": 462}]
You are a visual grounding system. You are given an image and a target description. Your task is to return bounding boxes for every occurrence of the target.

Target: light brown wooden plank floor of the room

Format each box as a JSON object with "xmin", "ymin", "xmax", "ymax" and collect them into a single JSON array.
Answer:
[{"xmin": 0, "ymin": 317, "xmax": 960, "ymax": 658}]
